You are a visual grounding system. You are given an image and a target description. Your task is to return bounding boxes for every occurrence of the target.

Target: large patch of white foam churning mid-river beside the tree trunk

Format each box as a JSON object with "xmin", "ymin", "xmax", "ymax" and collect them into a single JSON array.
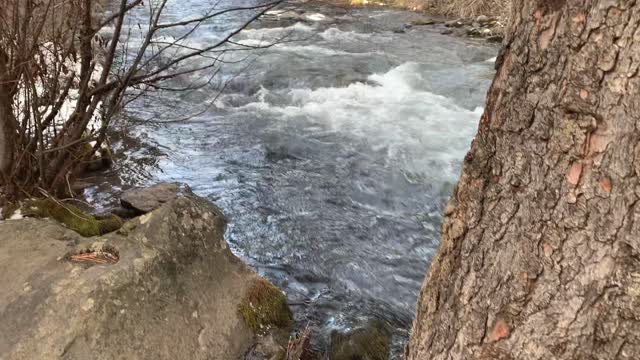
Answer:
[{"xmin": 235, "ymin": 63, "xmax": 482, "ymax": 182}]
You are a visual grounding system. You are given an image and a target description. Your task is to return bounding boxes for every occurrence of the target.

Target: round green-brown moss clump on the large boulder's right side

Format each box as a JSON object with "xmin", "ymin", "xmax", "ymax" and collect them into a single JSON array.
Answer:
[{"xmin": 238, "ymin": 279, "xmax": 293, "ymax": 335}]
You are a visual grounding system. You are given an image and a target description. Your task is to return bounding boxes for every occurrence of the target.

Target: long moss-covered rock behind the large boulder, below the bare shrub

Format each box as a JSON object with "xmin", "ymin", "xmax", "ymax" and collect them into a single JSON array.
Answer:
[{"xmin": 23, "ymin": 198, "xmax": 123, "ymax": 237}]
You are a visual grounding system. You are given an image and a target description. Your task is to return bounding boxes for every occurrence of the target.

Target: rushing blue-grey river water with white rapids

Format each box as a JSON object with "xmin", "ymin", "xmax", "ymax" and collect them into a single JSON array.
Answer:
[{"xmin": 107, "ymin": 0, "xmax": 497, "ymax": 357}]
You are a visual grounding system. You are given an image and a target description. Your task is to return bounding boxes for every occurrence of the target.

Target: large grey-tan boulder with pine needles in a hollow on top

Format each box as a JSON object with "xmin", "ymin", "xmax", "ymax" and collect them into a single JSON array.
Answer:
[{"xmin": 0, "ymin": 197, "xmax": 288, "ymax": 360}]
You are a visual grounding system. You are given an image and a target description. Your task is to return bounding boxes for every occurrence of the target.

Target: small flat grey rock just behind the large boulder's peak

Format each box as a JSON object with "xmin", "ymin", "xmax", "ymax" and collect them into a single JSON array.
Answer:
[{"xmin": 120, "ymin": 183, "xmax": 186, "ymax": 215}]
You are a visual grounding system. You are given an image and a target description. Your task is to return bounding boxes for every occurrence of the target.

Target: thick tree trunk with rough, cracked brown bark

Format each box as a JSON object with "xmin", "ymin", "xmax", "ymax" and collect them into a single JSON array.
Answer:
[{"xmin": 406, "ymin": 0, "xmax": 640, "ymax": 360}]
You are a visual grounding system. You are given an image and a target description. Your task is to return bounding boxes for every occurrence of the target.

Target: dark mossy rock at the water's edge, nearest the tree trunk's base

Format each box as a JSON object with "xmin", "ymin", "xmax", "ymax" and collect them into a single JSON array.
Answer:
[{"xmin": 330, "ymin": 320, "xmax": 391, "ymax": 360}]
